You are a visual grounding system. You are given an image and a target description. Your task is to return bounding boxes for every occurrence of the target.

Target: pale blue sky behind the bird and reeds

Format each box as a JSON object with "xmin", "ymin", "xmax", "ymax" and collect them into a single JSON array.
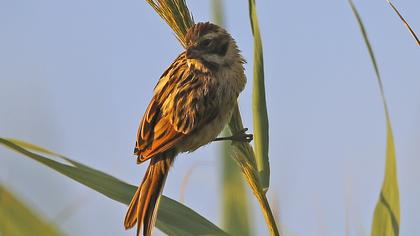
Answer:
[{"xmin": 0, "ymin": 0, "xmax": 420, "ymax": 236}]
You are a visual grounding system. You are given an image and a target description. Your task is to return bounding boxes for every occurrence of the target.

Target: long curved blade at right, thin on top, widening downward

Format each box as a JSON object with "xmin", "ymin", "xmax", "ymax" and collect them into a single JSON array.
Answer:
[{"xmin": 349, "ymin": 0, "xmax": 400, "ymax": 236}]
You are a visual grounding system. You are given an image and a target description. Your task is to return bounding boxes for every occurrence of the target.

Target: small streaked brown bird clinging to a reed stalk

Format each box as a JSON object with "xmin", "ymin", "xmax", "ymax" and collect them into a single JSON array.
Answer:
[{"xmin": 124, "ymin": 22, "xmax": 252, "ymax": 236}]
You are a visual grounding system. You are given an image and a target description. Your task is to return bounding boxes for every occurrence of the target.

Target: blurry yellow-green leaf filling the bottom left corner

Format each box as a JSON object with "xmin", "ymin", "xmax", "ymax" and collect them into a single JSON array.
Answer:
[{"xmin": 0, "ymin": 185, "xmax": 62, "ymax": 236}]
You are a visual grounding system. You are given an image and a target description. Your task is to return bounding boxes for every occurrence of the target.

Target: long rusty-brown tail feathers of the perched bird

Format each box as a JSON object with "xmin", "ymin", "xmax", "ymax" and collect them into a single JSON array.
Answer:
[{"xmin": 124, "ymin": 153, "xmax": 175, "ymax": 236}]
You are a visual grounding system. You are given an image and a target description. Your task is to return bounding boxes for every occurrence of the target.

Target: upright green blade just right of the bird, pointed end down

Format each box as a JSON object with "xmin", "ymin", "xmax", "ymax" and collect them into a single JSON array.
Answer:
[{"xmin": 249, "ymin": 0, "xmax": 270, "ymax": 192}]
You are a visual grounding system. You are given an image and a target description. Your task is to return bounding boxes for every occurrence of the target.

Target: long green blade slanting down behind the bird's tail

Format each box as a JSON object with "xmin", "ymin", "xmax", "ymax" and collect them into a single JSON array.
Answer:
[{"xmin": 0, "ymin": 138, "xmax": 227, "ymax": 236}]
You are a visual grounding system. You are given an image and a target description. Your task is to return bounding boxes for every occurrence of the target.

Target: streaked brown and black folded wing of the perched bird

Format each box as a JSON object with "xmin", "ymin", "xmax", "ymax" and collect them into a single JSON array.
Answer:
[{"xmin": 134, "ymin": 53, "xmax": 219, "ymax": 162}]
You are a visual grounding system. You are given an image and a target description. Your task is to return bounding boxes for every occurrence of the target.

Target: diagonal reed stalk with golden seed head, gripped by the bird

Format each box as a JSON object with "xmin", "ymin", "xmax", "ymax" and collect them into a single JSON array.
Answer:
[{"xmin": 146, "ymin": 0, "xmax": 280, "ymax": 236}]
